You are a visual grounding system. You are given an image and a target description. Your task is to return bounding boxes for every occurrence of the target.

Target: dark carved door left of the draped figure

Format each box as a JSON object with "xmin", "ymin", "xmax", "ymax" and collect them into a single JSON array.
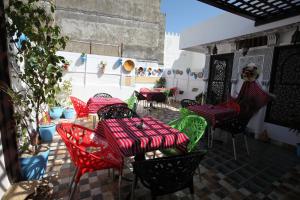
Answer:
[{"xmin": 206, "ymin": 53, "xmax": 234, "ymax": 104}]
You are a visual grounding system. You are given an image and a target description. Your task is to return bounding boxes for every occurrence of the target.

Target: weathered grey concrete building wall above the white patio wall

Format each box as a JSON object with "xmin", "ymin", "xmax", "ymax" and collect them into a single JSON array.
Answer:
[{"xmin": 55, "ymin": 0, "xmax": 165, "ymax": 63}]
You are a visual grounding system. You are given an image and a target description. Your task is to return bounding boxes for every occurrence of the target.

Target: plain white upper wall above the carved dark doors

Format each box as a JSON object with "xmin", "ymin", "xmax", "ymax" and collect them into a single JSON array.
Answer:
[{"xmin": 180, "ymin": 13, "xmax": 300, "ymax": 50}]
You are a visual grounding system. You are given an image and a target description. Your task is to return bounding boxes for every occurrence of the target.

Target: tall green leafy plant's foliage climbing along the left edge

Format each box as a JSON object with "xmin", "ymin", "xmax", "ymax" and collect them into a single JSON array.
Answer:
[{"xmin": 1, "ymin": 0, "xmax": 68, "ymax": 153}]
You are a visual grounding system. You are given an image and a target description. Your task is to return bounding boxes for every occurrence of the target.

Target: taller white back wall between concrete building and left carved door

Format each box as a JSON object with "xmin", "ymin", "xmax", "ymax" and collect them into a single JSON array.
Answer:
[{"xmin": 164, "ymin": 33, "xmax": 205, "ymax": 100}]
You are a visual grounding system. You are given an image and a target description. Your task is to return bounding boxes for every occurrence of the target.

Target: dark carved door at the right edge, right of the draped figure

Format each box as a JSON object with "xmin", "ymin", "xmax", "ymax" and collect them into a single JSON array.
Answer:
[{"xmin": 266, "ymin": 45, "xmax": 300, "ymax": 130}]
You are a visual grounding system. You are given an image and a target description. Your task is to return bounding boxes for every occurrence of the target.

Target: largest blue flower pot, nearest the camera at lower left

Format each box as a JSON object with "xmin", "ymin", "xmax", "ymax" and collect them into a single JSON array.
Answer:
[{"xmin": 19, "ymin": 150, "xmax": 50, "ymax": 180}]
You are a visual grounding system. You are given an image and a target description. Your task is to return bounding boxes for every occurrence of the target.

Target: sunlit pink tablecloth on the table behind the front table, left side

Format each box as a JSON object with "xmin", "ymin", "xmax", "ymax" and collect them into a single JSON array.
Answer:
[{"xmin": 87, "ymin": 97, "xmax": 126, "ymax": 114}]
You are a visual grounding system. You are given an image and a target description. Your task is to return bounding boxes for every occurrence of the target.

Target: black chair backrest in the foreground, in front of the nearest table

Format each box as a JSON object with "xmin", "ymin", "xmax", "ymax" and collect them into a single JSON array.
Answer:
[{"xmin": 133, "ymin": 151, "xmax": 206, "ymax": 195}]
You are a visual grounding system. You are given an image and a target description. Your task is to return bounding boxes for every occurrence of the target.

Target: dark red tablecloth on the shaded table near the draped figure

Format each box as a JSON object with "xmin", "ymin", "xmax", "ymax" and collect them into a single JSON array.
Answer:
[{"xmin": 187, "ymin": 104, "xmax": 238, "ymax": 127}]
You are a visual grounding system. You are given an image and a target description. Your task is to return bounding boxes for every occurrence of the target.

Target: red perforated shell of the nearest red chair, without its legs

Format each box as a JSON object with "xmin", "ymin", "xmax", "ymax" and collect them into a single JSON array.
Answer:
[{"xmin": 56, "ymin": 123, "xmax": 122, "ymax": 168}]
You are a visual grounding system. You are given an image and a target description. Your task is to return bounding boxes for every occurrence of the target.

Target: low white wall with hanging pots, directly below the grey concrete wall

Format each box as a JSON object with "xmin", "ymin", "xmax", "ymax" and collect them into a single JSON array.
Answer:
[{"xmin": 58, "ymin": 51, "xmax": 161, "ymax": 102}]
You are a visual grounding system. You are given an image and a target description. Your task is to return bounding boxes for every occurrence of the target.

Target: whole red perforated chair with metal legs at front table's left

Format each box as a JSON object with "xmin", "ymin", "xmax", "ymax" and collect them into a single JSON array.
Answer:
[{"xmin": 56, "ymin": 123, "xmax": 123, "ymax": 199}]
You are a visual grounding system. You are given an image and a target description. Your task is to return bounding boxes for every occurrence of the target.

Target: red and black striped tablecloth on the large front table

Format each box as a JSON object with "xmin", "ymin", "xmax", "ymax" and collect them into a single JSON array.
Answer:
[{"xmin": 95, "ymin": 117, "xmax": 189, "ymax": 157}]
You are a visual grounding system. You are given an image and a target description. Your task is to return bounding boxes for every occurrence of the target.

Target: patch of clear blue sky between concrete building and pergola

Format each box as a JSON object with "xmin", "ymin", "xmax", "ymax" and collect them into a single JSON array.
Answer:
[{"xmin": 161, "ymin": 0, "xmax": 224, "ymax": 33}]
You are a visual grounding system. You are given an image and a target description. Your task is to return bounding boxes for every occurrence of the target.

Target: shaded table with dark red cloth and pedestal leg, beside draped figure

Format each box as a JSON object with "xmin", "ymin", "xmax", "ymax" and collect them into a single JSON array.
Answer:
[{"xmin": 187, "ymin": 104, "xmax": 238, "ymax": 147}]
